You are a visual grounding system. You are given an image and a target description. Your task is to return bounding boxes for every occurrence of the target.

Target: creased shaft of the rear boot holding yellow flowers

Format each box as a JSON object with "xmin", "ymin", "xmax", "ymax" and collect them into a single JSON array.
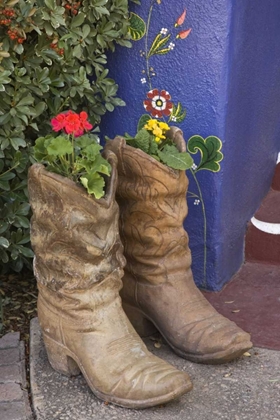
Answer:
[{"xmin": 106, "ymin": 130, "xmax": 191, "ymax": 284}]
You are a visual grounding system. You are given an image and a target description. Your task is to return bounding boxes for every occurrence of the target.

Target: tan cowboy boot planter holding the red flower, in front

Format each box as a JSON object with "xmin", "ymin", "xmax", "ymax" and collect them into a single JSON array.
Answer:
[{"xmin": 29, "ymin": 152, "xmax": 192, "ymax": 408}]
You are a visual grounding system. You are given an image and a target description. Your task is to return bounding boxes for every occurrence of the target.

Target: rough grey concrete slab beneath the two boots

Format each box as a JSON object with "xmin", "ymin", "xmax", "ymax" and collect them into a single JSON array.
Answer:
[{"xmin": 30, "ymin": 319, "xmax": 280, "ymax": 420}]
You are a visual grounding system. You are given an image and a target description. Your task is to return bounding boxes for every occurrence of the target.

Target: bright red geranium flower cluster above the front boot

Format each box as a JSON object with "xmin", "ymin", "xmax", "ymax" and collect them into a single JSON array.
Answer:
[{"xmin": 51, "ymin": 111, "xmax": 93, "ymax": 137}]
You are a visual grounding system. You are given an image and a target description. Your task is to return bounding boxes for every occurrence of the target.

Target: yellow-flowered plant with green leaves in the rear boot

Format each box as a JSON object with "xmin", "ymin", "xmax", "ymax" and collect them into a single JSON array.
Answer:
[{"xmin": 121, "ymin": 115, "xmax": 193, "ymax": 170}]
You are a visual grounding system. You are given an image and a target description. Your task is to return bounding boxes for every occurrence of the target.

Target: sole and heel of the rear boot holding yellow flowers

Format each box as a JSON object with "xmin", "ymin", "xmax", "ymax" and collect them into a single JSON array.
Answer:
[{"xmin": 123, "ymin": 303, "xmax": 253, "ymax": 365}]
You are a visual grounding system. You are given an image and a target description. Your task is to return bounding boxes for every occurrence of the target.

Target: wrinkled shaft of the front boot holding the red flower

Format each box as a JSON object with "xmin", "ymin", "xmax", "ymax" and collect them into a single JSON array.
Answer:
[{"xmin": 28, "ymin": 154, "xmax": 125, "ymax": 291}]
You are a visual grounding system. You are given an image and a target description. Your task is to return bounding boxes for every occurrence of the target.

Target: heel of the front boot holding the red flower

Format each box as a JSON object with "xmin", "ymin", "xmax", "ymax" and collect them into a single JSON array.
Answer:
[{"xmin": 43, "ymin": 334, "xmax": 81, "ymax": 376}]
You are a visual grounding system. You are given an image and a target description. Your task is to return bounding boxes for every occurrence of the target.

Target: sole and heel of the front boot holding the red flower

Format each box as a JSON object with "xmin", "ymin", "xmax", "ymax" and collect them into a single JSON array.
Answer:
[{"xmin": 43, "ymin": 333, "xmax": 192, "ymax": 409}]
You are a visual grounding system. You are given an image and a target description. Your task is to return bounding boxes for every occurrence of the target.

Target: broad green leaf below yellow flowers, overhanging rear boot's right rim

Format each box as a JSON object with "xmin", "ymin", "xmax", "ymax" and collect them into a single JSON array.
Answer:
[{"xmin": 158, "ymin": 144, "xmax": 193, "ymax": 170}]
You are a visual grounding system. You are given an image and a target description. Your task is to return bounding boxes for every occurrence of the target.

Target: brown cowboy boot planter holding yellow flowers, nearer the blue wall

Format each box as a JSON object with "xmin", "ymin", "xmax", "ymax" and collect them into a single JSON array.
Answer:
[{"xmin": 106, "ymin": 132, "xmax": 252, "ymax": 364}]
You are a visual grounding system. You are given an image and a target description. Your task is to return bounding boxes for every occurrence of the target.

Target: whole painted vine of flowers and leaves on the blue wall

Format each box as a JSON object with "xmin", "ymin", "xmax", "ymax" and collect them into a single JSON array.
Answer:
[{"xmin": 130, "ymin": 0, "xmax": 223, "ymax": 287}]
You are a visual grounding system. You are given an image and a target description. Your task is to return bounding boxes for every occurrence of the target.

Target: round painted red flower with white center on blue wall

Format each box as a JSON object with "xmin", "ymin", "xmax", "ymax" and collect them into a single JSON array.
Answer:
[{"xmin": 144, "ymin": 89, "xmax": 173, "ymax": 118}]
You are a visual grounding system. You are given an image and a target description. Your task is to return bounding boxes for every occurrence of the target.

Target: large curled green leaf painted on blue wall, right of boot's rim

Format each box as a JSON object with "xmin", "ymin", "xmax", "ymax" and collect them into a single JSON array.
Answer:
[{"xmin": 188, "ymin": 135, "xmax": 224, "ymax": 172}]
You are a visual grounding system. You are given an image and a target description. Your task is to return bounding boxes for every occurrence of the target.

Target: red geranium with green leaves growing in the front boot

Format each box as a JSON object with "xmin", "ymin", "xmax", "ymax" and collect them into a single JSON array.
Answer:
[{"xmin": 34, "ymin": 111, "xmax": 111, "ymax": 198}]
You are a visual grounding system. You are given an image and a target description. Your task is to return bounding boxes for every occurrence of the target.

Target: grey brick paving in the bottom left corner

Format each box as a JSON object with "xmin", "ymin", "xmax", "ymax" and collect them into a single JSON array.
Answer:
[{"xmin": 0, "ymin": 332, "xmax": 33, "ymax": 420}]
